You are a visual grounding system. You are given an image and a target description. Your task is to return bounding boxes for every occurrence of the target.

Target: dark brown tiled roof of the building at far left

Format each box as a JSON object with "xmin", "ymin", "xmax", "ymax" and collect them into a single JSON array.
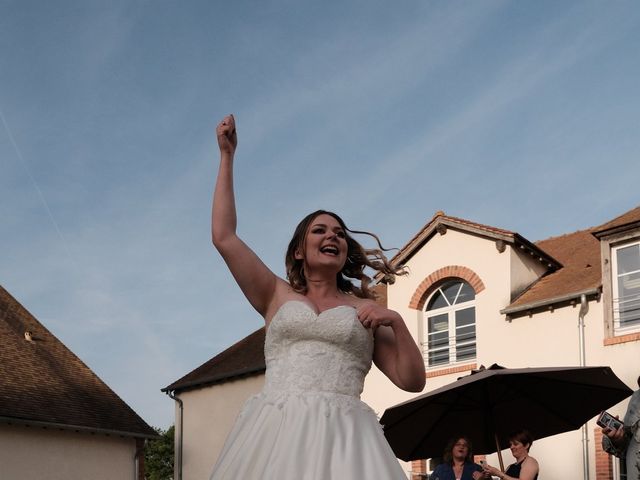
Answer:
[{"xmin": 0, "ymin": 286, "xmax": 157, "ymax": 437}]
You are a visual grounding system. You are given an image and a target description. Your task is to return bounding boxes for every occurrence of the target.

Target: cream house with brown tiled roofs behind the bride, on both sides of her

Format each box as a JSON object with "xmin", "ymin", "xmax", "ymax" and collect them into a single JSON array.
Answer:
[{"xmin": 166, "ymin": 207, "xmax": 640, "ymax": 480}]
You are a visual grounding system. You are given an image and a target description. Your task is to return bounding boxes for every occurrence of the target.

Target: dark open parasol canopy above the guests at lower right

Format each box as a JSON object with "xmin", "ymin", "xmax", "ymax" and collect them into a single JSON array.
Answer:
[{"xmin": 380, "ymin": 366, "xmax": 632, "ymax": 461}]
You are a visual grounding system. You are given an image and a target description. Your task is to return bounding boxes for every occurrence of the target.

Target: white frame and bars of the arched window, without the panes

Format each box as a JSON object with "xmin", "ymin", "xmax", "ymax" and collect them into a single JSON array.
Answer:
[{"xmin": 420, "ymin": 278, "xmax": 478, "ymax": 370}]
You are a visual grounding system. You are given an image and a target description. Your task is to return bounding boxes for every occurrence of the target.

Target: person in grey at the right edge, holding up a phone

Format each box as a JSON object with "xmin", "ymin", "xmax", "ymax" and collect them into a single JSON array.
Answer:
[{"xmin": 602, "ymin": 376, "xmax": 640, "ymax": 480}]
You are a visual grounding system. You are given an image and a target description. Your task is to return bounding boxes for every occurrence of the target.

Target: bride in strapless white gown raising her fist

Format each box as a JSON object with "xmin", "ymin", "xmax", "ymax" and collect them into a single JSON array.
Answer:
[{"xmin": 211, "ymin": 115, "xmax": 425, "ymax": 480}]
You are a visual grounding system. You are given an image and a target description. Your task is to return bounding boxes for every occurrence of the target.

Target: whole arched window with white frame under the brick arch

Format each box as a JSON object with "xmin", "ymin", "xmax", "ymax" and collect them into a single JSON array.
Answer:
[{"xmin": 422, "ymin": 278, "xmax": 476, "ymax": 367}]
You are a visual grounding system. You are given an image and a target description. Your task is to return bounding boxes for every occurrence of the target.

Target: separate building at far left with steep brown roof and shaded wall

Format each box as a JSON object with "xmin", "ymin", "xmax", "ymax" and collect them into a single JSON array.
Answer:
[{"xmin": 0, "ymin": 286, "xmax": 157, "ymax": 480}]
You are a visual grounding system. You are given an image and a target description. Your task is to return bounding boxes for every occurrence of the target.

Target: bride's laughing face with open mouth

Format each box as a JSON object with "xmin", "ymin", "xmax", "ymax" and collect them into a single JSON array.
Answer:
[{"xmin": 294, "ymin": 213, "xmax": 347, "ymax": 273}]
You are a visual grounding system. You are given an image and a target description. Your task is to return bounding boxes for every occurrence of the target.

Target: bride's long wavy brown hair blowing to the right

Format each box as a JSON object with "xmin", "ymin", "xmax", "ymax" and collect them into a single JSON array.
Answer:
[{"xmin": 285, "ymin": 210, "xmax": 406, "ymax": 298}]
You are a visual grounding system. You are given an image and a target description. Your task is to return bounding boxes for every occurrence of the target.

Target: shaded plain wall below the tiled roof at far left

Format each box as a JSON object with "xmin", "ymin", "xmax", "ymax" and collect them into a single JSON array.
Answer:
[{"xmin": 0, "ymin": 424, "xmax": 136, "ymax": 480}]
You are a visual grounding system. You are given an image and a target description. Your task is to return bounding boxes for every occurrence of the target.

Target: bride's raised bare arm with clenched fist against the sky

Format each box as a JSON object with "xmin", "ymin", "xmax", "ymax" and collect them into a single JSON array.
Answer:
[{"xmin": 211, "ymin": 115, "xmax": 279, "ymax": 317}]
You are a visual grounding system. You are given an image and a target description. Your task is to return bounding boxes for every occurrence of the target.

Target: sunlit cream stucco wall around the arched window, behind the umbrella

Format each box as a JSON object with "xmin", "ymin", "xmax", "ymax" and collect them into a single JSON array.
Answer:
[{"xmin": 363, "ymin": 229, "xmax": 640, "ymax": 480}]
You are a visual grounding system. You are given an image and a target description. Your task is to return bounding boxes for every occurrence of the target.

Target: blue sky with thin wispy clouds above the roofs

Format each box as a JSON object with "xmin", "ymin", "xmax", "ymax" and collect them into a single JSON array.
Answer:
[{"xmin": 0, "ymin": 0, "xmax": 640, "ymax": 428}]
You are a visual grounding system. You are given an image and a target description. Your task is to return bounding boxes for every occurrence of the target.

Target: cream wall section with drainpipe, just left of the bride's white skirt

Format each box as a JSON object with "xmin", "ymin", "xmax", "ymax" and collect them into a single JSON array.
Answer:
[{"xmin": 176, "ymin": 375, "xmax": 264, "ymax": 480}]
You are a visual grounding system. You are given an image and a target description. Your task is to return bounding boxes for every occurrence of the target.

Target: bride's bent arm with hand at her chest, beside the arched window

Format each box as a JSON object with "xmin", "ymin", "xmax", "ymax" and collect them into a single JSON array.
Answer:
[{"xmin": 358, "ymin": 301, "xmax": 426, "ymax": 392}]
